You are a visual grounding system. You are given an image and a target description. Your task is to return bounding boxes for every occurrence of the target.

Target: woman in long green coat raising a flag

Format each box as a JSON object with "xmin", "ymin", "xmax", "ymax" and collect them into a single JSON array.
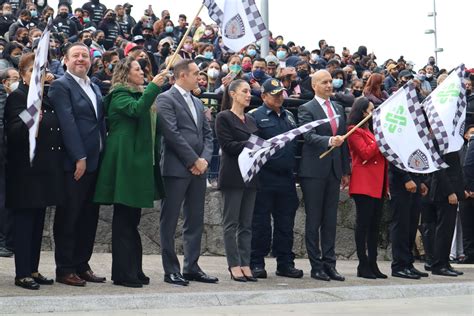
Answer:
[{"xmin": 94, "ymin": 58, "xmax": 166, "ymax": 287}]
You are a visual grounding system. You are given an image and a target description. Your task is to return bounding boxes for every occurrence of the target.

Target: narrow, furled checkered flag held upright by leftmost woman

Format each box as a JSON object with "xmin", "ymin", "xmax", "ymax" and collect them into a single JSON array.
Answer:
[{"xmin": 19, "ymin": 18, "xmax": 53, "ymax": 163}]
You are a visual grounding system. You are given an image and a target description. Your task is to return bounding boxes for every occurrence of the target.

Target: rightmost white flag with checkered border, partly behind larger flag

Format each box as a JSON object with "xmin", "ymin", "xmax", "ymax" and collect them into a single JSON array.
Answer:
[{"xmin": 422, "ymin": 64, "xmax": 467, "ymax": 155}]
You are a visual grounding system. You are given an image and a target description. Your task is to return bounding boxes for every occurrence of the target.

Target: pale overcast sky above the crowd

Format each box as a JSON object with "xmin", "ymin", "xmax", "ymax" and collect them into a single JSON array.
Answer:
[{"xmin": 49, "ymin": 0, "xmax": 474, "ymax": 69}]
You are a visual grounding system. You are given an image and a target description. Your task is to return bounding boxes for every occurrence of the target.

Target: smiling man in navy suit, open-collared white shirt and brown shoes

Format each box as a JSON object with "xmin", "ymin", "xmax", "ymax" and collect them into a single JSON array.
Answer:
[{"xmin": 48, "ymin": 43, "xmax": 105, "ymax": 286}]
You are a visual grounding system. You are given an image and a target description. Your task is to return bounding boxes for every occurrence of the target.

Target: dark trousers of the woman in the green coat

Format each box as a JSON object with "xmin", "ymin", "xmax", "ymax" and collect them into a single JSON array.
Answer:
[{"xmin": 112, "ymin": 204, "xmax": 144, "ymax": 283}]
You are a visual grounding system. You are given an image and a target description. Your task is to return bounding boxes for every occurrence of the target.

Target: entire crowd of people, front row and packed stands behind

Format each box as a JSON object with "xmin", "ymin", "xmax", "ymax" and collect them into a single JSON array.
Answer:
[{"xmin": 0, "ymin": 0, "xmax": 474, "ymax": 289}]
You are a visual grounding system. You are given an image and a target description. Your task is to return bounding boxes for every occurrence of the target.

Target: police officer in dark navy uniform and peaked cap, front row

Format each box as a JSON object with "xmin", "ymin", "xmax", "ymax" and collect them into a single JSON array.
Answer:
[{"xmin": 250, "ymin": 79, "xmax": 303, "ymax": 278}]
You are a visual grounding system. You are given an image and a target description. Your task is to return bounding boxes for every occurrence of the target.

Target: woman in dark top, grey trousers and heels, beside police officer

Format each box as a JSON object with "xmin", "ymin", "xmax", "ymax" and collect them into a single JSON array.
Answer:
[{"xmin": 216, "ymin": 79, "xmax": 257, "ymax": 282}]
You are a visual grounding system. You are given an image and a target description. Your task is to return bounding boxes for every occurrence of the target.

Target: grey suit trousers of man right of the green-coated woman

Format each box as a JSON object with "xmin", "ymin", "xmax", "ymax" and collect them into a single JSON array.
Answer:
[{"xmin": 160, "ymin": 176, "xmax": 206, "ymax": 274}]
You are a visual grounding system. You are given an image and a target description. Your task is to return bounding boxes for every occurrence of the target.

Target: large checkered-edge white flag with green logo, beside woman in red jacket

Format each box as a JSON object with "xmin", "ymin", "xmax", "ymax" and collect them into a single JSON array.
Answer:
[{"xmin": 372, "ymin": 81, "xmax": 448, "ymax": 173}]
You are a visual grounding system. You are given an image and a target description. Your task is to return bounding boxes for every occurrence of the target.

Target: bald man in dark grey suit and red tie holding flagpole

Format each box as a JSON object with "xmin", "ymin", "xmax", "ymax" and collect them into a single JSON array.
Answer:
[{"xmin": 298, "ymin": 70, "xmax": 350, "ymax": 281}]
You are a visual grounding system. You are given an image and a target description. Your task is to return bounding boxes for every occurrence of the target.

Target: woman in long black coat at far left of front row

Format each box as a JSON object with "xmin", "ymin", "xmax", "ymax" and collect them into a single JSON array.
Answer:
[{"xmin": 5, "ymin": 53, "xmax": 64, "ymax": 290}]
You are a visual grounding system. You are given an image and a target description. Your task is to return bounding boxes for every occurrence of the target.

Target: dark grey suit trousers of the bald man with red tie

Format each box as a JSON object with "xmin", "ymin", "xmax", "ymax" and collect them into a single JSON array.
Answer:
[{"xmin": 301, "ymin": 173, "xmax": 341, "ymax": 271}]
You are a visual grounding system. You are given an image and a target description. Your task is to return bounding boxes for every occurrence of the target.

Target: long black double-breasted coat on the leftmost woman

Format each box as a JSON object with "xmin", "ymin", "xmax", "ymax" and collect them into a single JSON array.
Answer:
[{"xmin": 5, "ymin": 83, "xmax": 64, "ymax": 209}]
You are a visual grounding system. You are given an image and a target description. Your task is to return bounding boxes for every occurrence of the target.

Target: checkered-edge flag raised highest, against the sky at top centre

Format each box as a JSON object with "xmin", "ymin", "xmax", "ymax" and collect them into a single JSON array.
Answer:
[{"xmin": 204, "ymin": 0, "xmax": 268, "ymax": 52}]
